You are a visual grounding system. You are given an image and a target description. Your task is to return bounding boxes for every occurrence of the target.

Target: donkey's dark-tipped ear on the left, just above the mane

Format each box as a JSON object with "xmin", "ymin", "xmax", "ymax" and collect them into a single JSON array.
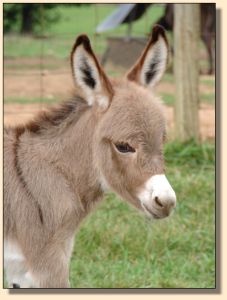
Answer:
[{"xmin": 71, "ymin": 35, "xmax": 113, "ymax": 109}]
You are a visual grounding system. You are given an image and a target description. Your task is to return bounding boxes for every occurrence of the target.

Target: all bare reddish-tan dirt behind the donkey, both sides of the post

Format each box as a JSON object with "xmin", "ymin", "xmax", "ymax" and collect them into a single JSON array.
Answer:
[{"xmin": 4, "ymin": 58, "xmax": 215, "ymax": 140}]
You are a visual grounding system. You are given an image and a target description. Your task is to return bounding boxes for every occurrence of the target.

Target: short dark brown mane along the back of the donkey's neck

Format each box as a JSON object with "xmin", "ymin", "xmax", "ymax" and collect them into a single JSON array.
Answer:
[{"xmin": 4, "ymin": 92, "xmax": 89, "ymax": 137}]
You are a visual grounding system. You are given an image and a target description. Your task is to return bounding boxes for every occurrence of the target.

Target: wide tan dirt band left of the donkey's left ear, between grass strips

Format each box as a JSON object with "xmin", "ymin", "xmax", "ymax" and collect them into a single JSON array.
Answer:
[{"xmin": 4, "ymin": 58, "xmax": 73, "ymax": 99}]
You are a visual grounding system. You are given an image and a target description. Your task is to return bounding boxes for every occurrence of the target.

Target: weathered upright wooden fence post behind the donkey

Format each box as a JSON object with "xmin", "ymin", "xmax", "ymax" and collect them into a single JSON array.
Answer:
[{"xmin": 174, "ymin": 4, "xmax": 200, "ymax": 141}]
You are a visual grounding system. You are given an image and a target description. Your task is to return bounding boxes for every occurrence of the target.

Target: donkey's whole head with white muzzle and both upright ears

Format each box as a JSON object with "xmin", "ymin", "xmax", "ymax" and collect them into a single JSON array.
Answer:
[{"xmin": 71, "ymin": 26, "xmax": 176, "ymax": 218}]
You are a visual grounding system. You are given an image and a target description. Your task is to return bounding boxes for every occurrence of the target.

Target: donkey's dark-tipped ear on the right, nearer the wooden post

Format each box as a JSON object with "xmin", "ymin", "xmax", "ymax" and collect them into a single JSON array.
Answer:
[{"xmin": 127, "ymin": 25, "xmax": 168, "ymax": 87}]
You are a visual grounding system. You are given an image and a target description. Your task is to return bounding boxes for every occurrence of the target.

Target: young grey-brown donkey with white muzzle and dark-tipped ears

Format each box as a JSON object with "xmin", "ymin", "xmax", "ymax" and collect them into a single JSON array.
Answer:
[{"xmin": 4, "ymin": 26, "xmax": 176, "ymax": 288}]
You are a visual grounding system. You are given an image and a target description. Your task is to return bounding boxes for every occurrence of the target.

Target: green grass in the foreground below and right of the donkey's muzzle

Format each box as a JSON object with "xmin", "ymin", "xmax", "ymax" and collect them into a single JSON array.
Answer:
[{"xmin": 70, "ymin": 142, "xmax": 215, "ymax": 288}]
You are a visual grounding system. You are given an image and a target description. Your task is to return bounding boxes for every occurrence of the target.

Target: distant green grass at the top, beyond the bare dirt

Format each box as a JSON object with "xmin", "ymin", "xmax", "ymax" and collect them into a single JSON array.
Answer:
[{"xmin": 4, "ymin": 4, "xmax": 164, "ymax": 58}]
